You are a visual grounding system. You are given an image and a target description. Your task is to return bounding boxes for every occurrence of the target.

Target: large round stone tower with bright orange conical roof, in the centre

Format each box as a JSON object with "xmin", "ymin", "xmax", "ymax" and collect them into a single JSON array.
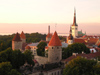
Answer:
[{"xmin": 48, "ymin": 31, "xmax": 62, "ymax": 63}]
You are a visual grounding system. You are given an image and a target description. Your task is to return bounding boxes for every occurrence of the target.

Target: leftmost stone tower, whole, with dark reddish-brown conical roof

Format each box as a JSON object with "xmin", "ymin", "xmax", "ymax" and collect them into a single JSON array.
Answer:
[{"xmin": 12, "ymin": 32, "xmax": 22, "ymax": 50}]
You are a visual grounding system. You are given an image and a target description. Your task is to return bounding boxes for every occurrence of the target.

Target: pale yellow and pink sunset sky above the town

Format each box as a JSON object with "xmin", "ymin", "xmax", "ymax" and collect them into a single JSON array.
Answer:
[{"xmin": 0, "ymin": 0, "xmax": 100, "ymax": 34}]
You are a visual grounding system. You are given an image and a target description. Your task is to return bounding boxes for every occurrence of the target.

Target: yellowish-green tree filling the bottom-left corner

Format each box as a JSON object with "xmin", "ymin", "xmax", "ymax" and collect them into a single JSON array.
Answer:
[{"xmin": 0, "ymin": 62, "xmax": 21, "ymax": 75}]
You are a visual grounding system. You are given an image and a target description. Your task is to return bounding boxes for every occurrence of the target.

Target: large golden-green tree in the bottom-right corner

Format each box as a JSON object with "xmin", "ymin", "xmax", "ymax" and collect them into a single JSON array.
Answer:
[{"xmin": 63, "ymin": 57, "xmax": 97, "ymax": 75}]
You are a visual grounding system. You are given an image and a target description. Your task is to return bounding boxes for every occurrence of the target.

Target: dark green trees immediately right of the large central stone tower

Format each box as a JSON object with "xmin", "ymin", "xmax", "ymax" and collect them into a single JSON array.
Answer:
[{"xmin": 62, "ymin": 43, "xmax": 90, "ymax": 59}]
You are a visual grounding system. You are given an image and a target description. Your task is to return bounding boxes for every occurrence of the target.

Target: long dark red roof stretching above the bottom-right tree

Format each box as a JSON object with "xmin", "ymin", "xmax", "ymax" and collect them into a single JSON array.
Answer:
[{"xmin": 65, "ymin": 52, "xmax": 100, "ymax": 62}]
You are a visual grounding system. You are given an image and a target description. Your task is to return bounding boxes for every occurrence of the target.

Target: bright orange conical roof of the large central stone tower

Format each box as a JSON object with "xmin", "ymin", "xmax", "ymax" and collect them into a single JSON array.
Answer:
[{"xmin": 49, "ymin": 31, "xmax": 62, "ymax": 46}]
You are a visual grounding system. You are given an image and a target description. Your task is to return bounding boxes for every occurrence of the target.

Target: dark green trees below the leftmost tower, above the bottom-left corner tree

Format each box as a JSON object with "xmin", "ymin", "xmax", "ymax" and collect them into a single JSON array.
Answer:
[{"xmin": 0, "ymin": 48, "xmax": 25, "ymax": 69}]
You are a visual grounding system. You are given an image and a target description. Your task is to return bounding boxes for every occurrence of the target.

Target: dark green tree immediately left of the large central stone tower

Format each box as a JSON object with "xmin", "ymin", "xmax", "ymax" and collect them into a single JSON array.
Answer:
[{"xmin": 37, "ymin": 42, "xmax": 47, "ymax": 56}]
